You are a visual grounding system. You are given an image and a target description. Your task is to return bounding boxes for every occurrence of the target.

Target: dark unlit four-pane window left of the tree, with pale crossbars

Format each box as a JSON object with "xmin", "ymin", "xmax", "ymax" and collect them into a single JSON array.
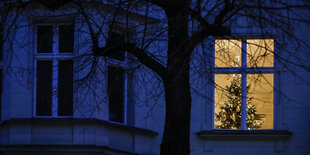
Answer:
[{"xmin": 35, "ymin": 25, "xmax": 74, "ymax": 117}]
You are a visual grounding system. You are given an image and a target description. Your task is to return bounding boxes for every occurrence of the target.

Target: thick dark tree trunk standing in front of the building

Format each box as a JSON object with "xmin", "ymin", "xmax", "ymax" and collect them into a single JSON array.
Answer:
[{"xmin": 160, "ymin": 0, "xmax": 192, "ymax": 155}]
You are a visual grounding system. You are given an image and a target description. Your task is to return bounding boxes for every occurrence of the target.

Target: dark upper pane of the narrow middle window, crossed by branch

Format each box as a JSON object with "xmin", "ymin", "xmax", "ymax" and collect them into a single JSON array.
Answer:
[{"xmin": 107, "ymin": 32, "xmax": 125, "ymax": 60}]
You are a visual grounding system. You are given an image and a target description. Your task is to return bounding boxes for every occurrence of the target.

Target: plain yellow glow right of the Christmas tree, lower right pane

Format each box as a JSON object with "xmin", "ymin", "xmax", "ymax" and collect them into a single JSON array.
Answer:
[{"xmin": 247, "ymin": 74, "xmax": 273, "ymax": 129}]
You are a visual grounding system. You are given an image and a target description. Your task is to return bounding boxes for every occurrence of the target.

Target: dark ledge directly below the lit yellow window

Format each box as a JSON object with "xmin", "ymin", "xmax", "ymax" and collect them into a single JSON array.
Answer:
[{"xmin": 197, "ymin": 130, "xmax": 292, "ymax": 141}]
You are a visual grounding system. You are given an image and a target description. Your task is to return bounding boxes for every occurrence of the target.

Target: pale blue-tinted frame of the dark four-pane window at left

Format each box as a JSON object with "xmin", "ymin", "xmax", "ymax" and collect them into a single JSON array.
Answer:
[{"xmin": 33, "ymin": 23, "xmax": 75, "ymax": 118}]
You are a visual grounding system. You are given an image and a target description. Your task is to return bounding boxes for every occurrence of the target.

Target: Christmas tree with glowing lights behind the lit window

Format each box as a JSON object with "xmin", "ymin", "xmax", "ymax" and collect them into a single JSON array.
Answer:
[{"xmin": 215, "ymin": 74, "xmax": 263, "ymax": 129}]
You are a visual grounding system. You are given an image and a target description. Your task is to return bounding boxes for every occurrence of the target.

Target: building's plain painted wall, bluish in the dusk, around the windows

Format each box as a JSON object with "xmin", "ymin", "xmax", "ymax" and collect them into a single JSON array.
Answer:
[{"xmin": 0, "ymin": 1, "xmax": 310, "ymax": 155}]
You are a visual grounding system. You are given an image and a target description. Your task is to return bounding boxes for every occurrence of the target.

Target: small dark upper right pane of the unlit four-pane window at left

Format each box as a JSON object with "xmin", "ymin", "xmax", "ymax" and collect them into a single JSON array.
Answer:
[{"xmin": 59, "ymin": 25, "xmax": 74, "ymax": 53}]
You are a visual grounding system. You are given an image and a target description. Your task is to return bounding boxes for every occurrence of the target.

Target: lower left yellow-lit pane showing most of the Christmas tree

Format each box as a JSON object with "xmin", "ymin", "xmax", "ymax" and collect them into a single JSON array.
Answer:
[{"xmin": 214, "ymin": 74, "xmax": 241, "ymax": 129}]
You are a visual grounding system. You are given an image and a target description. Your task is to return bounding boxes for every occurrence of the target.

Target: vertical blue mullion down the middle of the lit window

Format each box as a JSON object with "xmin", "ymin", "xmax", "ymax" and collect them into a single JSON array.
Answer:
[{"xmin": 241, "ymin": 40, "xmax": 247, "ymax": 130}]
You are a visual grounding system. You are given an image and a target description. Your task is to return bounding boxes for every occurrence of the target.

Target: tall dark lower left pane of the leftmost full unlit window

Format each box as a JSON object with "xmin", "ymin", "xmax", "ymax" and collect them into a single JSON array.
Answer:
[{"xmin": 36, "ymin": 60, "xmax": 52, "ymax": 116}]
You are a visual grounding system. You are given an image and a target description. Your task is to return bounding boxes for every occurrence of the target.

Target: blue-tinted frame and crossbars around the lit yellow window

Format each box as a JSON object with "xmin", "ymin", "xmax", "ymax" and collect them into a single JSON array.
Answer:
[{"xmin": 207, "ymin": 36, "xmax": 280, "ymax": 131}]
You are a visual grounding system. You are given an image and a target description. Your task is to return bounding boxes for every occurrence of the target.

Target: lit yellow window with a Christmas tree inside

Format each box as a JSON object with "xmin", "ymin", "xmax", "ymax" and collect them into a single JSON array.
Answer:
[{"xmin": 214, "ymin": 39, "xmax": 274, "ymax": 130}]
